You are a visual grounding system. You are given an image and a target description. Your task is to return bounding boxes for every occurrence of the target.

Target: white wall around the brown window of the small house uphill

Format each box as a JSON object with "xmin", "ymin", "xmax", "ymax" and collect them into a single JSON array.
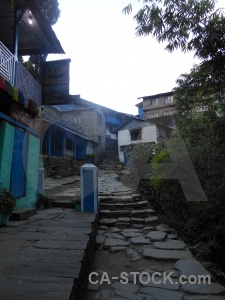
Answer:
[{"xmin": 118, "ymin": 124, "xmax": 157, "ymax": 162}]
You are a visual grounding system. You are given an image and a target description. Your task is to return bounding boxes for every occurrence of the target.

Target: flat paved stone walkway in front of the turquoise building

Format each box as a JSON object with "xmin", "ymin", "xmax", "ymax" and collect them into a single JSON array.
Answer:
[{"xmin": 0, "ymin": 208, "xmax": 96, "ymax": 300}]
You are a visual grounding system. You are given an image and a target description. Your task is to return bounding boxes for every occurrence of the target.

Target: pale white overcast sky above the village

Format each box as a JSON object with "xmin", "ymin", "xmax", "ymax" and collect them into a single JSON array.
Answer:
[{"xmin": 48, "ymin": 0, "xmax": 214, "ymax": 115}]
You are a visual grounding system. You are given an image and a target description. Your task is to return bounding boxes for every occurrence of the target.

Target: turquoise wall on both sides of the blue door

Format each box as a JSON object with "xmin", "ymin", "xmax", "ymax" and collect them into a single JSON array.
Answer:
[{"xmin": 0, "ymin": 122, "xmax": 40, "ymax": 210}]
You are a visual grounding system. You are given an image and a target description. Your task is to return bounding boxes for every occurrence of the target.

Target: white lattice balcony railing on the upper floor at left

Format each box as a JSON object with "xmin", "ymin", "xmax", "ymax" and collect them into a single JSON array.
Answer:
[{"xmin": 0, "ymin": 41, "xmax": 41, "ymax": 105}]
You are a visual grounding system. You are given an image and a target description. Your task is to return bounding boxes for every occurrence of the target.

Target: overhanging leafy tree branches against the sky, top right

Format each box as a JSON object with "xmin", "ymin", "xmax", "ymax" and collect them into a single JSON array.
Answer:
[{"xmin": 123, "ymin": 0, "xmax": 225, "ymax": 59}]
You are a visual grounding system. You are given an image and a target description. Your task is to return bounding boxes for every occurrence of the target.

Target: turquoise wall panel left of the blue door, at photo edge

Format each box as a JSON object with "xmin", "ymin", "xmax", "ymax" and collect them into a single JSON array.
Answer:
[{"xmin": 0, "ymin": 122, "xmax": 14, "ymax": 190}]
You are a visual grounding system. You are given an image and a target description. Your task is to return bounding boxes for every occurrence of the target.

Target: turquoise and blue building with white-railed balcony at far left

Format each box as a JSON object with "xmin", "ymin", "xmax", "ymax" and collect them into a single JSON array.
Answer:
[{"xmin": 0, "ymin": 0, "xmax": 64, "ymax": 209}]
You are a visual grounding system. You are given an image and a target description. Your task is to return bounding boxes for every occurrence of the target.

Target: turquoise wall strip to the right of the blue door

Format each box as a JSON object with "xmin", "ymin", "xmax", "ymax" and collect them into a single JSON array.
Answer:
[{"xmin": 16, "ymin": 134, "xmax": 40, "ymax": 209}]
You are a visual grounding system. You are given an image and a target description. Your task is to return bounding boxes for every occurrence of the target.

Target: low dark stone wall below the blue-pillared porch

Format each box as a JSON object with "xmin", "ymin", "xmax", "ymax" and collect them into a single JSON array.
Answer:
[{"xmin": 42, "ymin": 155, "xmax": 85, "ymax": 177}]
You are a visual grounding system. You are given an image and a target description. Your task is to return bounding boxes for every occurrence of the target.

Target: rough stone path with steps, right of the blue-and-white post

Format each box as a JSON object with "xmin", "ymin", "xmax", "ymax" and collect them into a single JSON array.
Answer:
[{"xmin": 85, "ymin": 170, "xmax": 225, "ymax": 300}]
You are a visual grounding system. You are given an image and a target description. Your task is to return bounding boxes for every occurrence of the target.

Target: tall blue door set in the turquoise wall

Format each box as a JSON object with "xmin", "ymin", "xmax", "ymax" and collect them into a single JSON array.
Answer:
[{"xmin": 10, "ymin": 128, "xmax": 26, "ymax": 198}]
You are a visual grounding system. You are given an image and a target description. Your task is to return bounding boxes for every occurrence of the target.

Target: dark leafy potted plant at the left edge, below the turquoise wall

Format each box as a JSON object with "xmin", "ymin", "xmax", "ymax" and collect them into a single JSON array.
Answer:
[{"xmin": 0, "ymin": 184, "xmax": 16, "ymax": 215}]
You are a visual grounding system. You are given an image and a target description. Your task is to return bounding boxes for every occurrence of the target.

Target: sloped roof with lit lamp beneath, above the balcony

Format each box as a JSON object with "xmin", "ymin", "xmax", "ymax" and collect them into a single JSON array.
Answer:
[{"xmin": 0, "ymin": 0, "xmax": 65, "ymax": 55}]
